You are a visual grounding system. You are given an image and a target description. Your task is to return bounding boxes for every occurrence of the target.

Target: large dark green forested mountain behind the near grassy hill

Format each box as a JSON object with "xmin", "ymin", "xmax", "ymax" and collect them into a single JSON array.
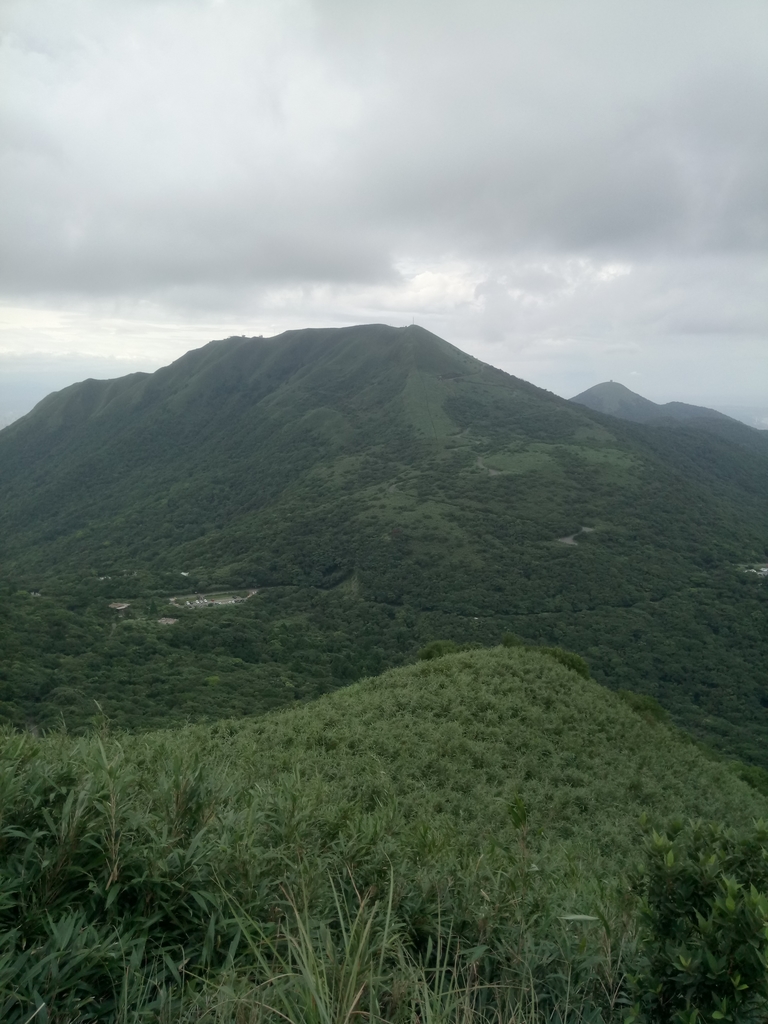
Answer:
[{"xmin": 0, "ymin": 325, "xmax": 768, "ymax": 762}]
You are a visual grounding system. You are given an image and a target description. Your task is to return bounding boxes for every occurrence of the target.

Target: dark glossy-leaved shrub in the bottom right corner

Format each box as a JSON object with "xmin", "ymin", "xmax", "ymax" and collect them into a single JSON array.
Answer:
[{"xmin": 632, "ymin": 821, "xmax": 768, "ymax": 1024}]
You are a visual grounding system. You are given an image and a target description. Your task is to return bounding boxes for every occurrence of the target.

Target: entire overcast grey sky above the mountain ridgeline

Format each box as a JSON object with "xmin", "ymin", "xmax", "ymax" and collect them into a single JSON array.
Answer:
[{"xmin": 0, "ymin": 0, "xmax": 768, "ymax": 425}]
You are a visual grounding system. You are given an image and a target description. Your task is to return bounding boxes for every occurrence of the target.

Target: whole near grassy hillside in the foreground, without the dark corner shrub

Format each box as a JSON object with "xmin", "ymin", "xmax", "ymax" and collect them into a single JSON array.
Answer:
[{"xmin": 0, "ymin": 648, "xmax": 768, "ymax": 1024}]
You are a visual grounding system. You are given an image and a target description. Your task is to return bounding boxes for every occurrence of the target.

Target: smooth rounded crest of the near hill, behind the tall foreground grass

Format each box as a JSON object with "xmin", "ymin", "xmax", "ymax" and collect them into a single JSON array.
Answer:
[{"xmin": 129, "ymin": 647, "xmax": 768, "ymax": 856}]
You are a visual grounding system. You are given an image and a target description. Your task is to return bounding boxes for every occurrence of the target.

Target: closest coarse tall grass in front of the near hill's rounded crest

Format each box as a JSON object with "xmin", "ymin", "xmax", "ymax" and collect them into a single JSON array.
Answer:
[{"xmin": 0, "ymin": 735, "xmax": 629, "ymax": 1024}]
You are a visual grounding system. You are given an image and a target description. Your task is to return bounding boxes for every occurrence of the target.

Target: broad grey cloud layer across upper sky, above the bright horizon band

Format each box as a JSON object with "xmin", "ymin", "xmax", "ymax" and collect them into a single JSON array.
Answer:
[{"xmin": 3, "ymin": 0, "xmax": 768, "ymax": 293}]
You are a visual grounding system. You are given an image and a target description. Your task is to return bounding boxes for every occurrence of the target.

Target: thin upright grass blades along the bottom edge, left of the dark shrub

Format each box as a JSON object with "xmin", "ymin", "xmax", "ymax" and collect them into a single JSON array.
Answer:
[{"xmin": 166, "ymin": 890, "xmax": 634, "ymax": 1024}]
